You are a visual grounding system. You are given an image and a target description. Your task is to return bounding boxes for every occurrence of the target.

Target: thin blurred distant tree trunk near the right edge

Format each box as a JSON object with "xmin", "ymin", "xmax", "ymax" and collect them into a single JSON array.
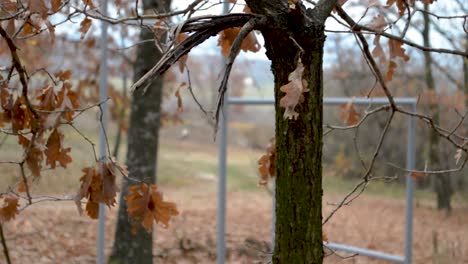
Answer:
[{"xmin": 422, "ymin": 4, "xmax": 453, "ymax": 212}]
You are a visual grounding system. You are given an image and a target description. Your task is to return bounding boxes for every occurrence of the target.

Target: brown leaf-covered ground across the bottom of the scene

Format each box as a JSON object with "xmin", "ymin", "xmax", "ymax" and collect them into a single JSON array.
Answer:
[{"xmin": 0, "ymin": 187, "xmax": 468, "ymax": 264}]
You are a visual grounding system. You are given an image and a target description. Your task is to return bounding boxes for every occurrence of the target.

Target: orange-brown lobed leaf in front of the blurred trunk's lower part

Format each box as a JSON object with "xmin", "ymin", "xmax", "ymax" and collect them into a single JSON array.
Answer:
[{"xmin": 125, "ymin": 183, "xmax": 179, "ymax": 232}]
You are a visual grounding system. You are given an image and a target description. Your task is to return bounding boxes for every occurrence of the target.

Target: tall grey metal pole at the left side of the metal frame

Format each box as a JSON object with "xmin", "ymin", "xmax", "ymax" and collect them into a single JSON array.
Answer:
[{"xmin": 216, "ymin": 1, "xmax": 229, "ymax": 264}]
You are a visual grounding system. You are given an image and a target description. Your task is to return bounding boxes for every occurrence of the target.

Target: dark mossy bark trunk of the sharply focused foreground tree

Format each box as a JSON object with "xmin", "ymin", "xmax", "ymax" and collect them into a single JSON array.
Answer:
[{"xmin": 246, "ymin": 0, "xmax": 336, "ymax": 264}]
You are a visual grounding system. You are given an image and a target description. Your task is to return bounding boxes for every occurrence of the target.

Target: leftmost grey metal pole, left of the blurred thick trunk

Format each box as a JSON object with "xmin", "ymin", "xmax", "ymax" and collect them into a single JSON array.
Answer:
[{"xmin": 96, "ymin": 0, "xmax": 108, "ymax": 264}]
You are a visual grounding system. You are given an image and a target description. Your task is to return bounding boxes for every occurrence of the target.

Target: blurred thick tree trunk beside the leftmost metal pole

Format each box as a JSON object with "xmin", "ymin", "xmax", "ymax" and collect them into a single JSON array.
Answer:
[{"xmin": 109, "ymin": 0, "xmax": 170, "ymax": 264}]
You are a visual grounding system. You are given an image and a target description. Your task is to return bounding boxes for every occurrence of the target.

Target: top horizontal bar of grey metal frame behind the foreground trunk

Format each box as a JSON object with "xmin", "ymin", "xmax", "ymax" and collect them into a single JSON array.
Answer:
[{"xmin": 227, "ymin": 97, "xmax": 417, "ymax": 105}]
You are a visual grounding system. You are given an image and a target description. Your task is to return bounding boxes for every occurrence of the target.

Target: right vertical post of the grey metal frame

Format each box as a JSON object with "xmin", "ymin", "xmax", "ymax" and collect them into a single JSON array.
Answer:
[{"xmin": 405, "ymin": 102, "xmax": 416, "ymax": 264}]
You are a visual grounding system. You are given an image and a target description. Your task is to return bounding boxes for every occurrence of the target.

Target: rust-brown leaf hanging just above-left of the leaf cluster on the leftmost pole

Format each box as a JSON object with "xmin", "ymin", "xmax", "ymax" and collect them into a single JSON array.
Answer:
[{"xmin": 44, "ymin": 129, "xmax": 72, "ymax": 169}]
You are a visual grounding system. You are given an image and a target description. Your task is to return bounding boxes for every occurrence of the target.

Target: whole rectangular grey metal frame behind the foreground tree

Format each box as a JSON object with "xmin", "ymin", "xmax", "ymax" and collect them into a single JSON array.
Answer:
[{"xmin": 217, "ymin": 97, "xmax": 417, "ymax": 264}]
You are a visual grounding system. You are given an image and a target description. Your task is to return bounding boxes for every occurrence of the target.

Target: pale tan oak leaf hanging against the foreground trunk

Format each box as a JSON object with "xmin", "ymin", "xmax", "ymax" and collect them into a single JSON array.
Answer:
[{"xmin": 280, "ymin": 59, "xmax": 309, "ymax": 119}]
